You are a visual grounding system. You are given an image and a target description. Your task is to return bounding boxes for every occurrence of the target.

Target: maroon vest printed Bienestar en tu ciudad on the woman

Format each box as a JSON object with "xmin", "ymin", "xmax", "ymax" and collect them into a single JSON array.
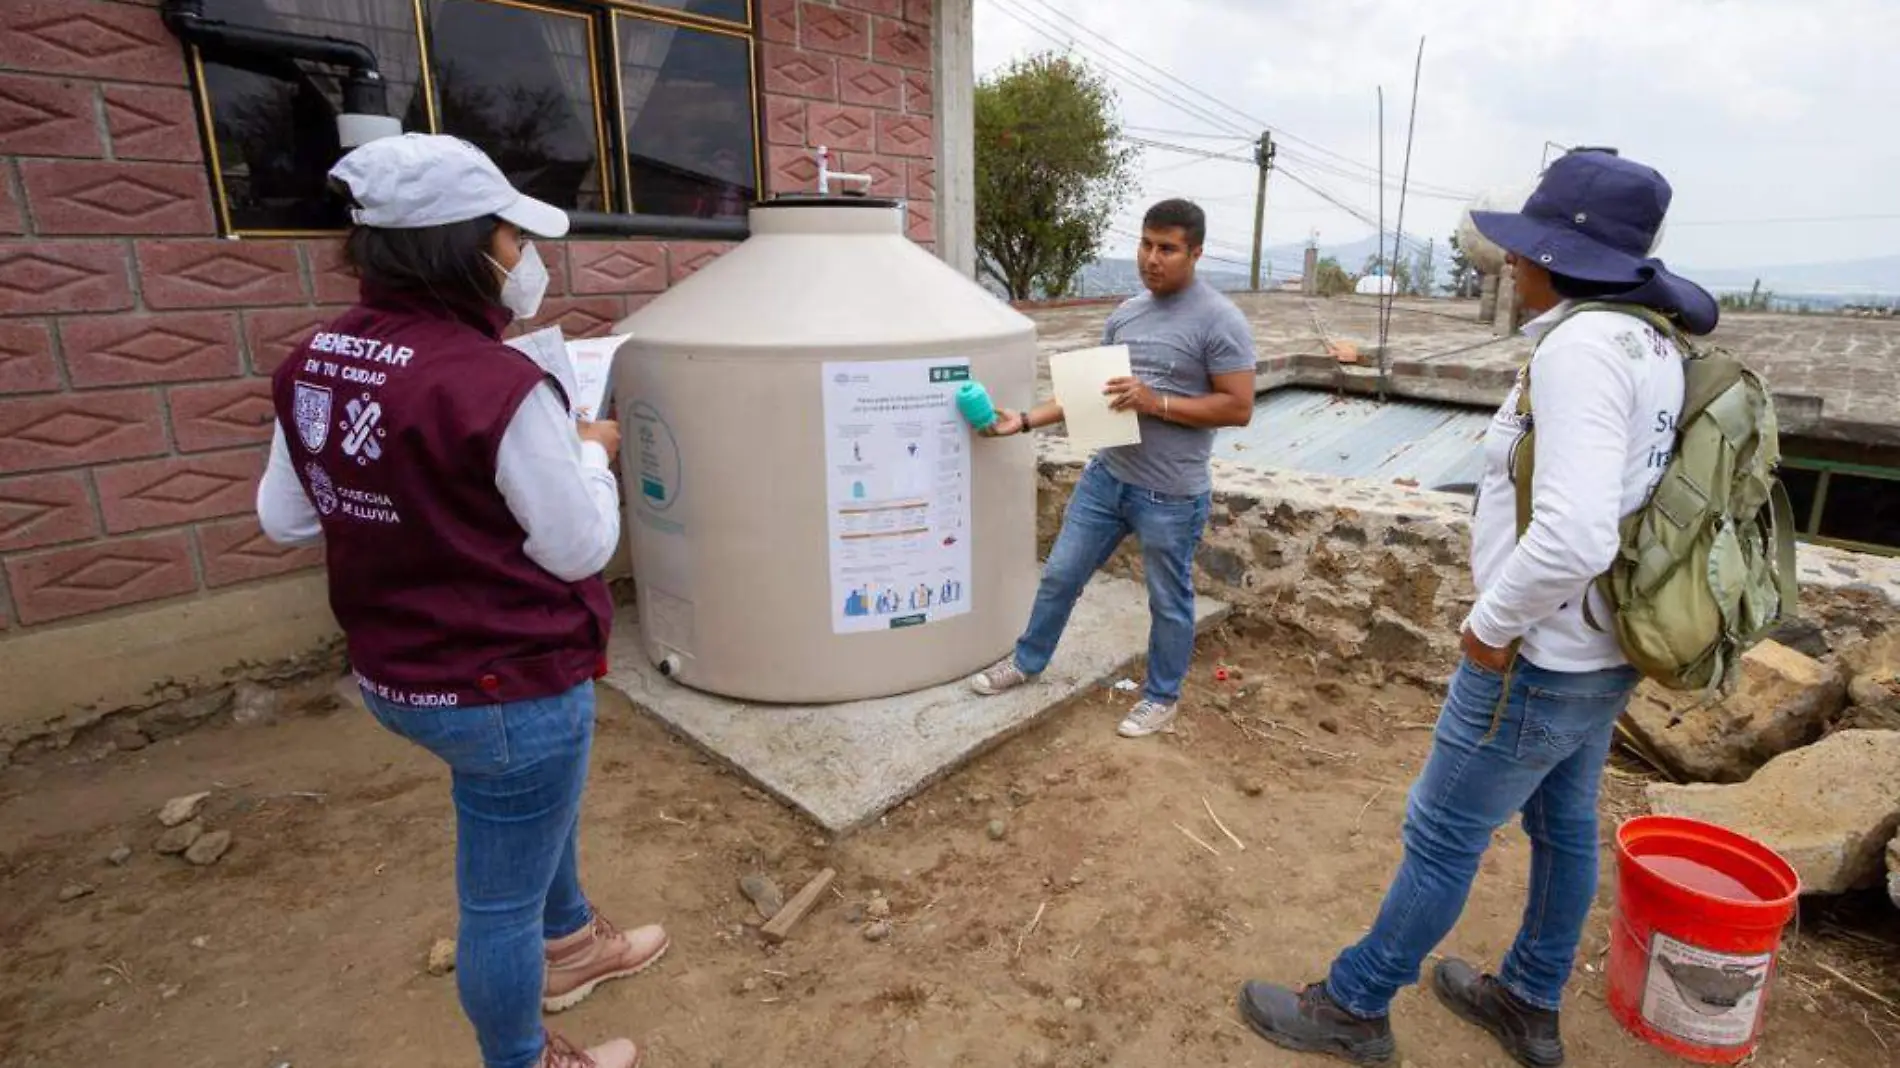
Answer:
[{"xmin": 272, "ymin": 287, "xmax": 612, "ymax": 707}]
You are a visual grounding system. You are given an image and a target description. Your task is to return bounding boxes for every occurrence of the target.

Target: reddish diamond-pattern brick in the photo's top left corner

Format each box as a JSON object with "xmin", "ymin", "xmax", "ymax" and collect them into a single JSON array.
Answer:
[{"xmin": 0, "ymin": 0, "xmax": 184, "ymax": 86}]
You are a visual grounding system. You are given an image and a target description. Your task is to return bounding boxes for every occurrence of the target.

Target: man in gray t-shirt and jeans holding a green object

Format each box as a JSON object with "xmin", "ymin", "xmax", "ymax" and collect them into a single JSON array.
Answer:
[{"xmin": 971, "ymin": 200, "xmax": 1256, "ymax": 737}]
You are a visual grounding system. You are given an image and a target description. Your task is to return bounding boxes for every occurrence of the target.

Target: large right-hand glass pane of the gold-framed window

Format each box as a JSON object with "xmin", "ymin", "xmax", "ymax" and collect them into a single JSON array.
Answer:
[{"xmin": 614, "ymin": 15, "xmax": 758, "ymax": 219}]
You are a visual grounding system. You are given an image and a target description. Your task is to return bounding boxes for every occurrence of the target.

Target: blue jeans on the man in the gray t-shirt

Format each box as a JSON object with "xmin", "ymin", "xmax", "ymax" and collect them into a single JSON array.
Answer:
[{"xmin": 1017, "ymin": 460, "xmax": 1212, "ymax": 705}]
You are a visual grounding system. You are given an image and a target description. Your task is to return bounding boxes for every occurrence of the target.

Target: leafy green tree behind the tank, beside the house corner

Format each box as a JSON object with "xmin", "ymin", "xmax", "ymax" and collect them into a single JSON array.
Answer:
[{"xmin": 977, "ymin": 53, "xmax": 1136, "ymax": 300}]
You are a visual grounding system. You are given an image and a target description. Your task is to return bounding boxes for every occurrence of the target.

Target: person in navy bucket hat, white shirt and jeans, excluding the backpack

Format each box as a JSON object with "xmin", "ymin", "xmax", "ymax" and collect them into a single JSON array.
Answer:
[{"xmin": 1239, "ymin": 150, "xmax": 1720, "ymax": 1068}]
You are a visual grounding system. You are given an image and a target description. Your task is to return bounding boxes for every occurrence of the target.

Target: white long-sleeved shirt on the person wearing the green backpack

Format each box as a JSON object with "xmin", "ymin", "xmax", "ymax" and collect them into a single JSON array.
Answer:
[{"xmin": 1465, "ymin": 306, "xmax": 1683, "ymax": 673}]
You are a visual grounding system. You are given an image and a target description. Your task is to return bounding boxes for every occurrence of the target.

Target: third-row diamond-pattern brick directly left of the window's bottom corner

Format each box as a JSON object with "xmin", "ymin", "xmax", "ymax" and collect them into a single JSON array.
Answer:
[{"xmin": 19, "ymin": 160, "xmax": 213, "ymax": 234}]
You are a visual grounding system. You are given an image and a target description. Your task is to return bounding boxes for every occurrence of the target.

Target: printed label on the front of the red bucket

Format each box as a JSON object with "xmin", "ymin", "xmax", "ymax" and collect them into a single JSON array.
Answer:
[{"xmin": 1644, "ymin": 933, "xmax": 1775, "ymax": 1047}]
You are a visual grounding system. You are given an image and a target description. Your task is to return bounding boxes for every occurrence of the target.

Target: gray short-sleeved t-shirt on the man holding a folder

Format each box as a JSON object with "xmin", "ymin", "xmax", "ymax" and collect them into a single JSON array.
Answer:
[{"xmin": 1102, "ymin": 279, "xmax": 1256, "ymax": 496}]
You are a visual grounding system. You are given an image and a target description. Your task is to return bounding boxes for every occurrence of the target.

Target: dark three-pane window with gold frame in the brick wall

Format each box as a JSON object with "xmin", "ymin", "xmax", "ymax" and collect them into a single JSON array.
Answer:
[{"xmin": 187, "ymin": 0, "xmax": 758, "ymax": 234}]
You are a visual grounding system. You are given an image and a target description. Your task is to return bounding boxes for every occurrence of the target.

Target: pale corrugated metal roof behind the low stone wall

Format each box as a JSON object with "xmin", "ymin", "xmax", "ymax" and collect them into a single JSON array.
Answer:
[{"xmin": 1214, "ymin": 390, "xmax": 1492, "ymax": 488}]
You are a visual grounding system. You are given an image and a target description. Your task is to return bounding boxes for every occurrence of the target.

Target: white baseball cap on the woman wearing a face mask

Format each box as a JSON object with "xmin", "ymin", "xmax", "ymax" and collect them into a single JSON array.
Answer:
[{"xmin": 331, "ymin": 133, "xmax": 568, "ymax": 238}]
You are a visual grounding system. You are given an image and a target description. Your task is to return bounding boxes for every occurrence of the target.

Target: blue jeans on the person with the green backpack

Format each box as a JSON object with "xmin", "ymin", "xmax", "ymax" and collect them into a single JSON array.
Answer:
[{"xmin": 1326, "ymin": 658, "xmax": 1638, "ymax": 1019}]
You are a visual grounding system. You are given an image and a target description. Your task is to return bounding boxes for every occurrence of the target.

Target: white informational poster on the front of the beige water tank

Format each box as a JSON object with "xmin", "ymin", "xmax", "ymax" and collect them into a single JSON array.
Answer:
[{"xmin": 823, "ymin": 357, "xmax": 971, "ymax": 635}]
